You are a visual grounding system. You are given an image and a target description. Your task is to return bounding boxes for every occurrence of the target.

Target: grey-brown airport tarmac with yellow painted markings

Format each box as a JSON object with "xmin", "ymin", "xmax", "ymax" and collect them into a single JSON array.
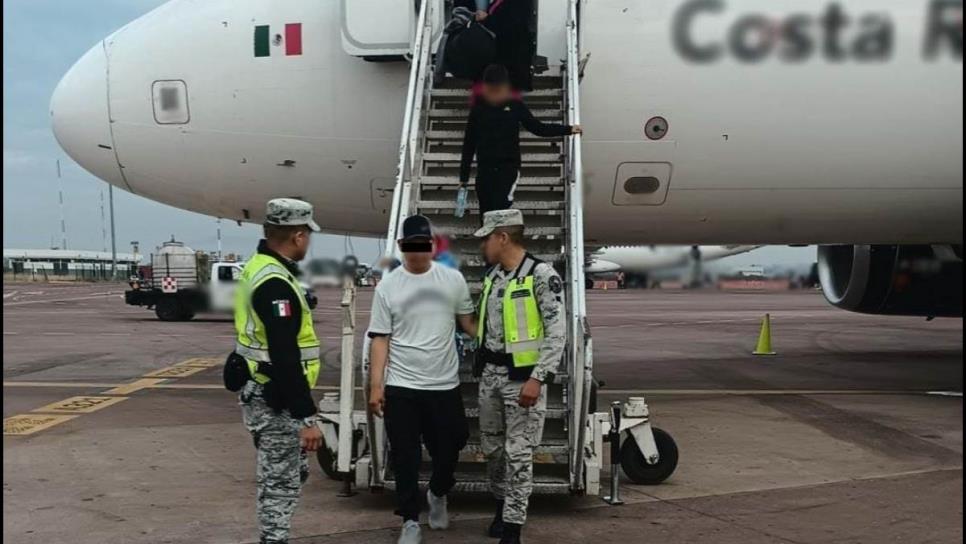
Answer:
[{"xmin": 3, "ymin": 284, "xmax": 963, "ymax": 544}]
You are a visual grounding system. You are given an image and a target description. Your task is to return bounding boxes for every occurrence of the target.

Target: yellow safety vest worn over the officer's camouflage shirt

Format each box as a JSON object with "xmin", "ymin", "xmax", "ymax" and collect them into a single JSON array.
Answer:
[{"xmin": 476, "ymin": 255, "xmax": 543, "ymax": 368}]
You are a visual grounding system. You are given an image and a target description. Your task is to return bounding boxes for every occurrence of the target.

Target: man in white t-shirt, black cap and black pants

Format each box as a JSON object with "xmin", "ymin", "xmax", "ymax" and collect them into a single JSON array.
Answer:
[{"xmin": 368, "ymin": 215, "xmax": 476, "ymax": 544}]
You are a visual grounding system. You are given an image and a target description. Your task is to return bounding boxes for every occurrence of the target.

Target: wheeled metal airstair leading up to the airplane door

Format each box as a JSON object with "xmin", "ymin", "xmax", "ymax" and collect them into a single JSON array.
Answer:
[{"xmin": 320, "ymin": 0, "xmax": 677, "ymax": 499}]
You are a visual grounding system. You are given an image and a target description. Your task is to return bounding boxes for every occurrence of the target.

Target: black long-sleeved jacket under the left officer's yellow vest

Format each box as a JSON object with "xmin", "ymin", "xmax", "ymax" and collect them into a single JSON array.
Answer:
[{"xmin": 252, "ymin": 240, "xmax": 317, "ymax": 418}]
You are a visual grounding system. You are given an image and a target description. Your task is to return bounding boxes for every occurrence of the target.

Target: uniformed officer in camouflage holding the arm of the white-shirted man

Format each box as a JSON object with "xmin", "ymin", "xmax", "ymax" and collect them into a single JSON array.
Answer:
[{"xmin": 475, "ymin": 209, "xmax": 566, "ymax": 544}]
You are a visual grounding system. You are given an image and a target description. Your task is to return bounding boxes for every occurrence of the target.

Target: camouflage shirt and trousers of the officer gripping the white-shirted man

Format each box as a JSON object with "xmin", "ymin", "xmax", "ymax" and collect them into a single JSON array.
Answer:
[{"xmin": 480, "ymin": 262, "xmax": 567, "ymax": 525}]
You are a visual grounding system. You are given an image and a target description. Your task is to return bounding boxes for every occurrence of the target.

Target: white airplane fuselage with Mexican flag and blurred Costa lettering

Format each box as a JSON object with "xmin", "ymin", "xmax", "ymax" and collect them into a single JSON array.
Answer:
[{"xmin": 51, "ymin": 0, "xmax": 963, "ymax": 245}]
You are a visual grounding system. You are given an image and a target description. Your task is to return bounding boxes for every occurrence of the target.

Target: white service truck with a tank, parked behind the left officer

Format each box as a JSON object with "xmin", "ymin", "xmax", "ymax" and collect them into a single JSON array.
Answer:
[{"xmin": 124, "ymin": 240, "xmax": 317, "ymax": 321}]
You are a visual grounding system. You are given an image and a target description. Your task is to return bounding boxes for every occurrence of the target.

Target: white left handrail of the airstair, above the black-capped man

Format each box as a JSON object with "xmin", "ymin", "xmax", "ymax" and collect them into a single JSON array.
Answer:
[{"xmin": 385, "ymin": 0, "xmax": 436, "ymax": 256}]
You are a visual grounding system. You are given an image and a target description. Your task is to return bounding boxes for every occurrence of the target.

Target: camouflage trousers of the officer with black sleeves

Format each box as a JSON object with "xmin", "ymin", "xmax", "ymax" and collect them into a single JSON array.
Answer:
[{"xmin": 239, "ymin": 381, "xmax": 309, "ymax": 543}]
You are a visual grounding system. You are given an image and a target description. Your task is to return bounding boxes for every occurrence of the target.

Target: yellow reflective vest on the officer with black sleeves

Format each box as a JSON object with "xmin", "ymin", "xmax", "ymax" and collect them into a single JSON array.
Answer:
[{"xmin": 235, "ymin": 253, "xmax": 321, "ymax": 389}]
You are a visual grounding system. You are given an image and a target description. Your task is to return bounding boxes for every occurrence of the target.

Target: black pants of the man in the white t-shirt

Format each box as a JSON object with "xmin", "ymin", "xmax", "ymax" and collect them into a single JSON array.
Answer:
[{"xmin": 384, "ymin": 386, "xmax": 469, "ymax": 521}]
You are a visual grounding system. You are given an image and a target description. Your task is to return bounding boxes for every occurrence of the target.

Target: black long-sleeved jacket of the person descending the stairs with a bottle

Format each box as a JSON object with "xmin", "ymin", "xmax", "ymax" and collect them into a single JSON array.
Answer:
[{"xmin": 460, "ymin": 100, "xmax": 572, "ymax": 182}]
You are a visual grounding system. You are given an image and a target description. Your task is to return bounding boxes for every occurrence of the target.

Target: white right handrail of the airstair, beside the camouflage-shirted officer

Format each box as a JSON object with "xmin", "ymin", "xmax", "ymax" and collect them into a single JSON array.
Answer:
[{"xmin": 566, "ymin": 0, "xmax": 591, "ymax": 491}]
